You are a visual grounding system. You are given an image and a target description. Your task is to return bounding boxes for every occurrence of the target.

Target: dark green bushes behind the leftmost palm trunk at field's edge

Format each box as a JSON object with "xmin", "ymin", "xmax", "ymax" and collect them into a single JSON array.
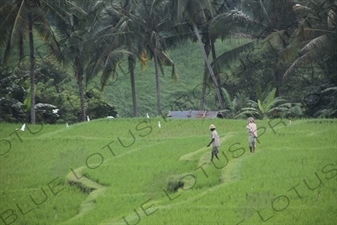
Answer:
[{"xmin": 0, "ymin": 60, "xmax": 117, "ymax": 124}]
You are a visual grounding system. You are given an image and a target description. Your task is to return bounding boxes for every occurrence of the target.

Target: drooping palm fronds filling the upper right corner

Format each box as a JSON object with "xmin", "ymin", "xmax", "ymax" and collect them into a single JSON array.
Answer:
[{"xmin": 281, "ymin": 0, "xmax": 337, "ymax": 77}]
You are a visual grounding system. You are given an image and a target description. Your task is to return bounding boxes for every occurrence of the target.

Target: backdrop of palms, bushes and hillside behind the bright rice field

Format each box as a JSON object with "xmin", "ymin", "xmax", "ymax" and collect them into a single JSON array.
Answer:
[{"xmin": 0, "ymin": 0, "xmax": 337, "ymax": 123}]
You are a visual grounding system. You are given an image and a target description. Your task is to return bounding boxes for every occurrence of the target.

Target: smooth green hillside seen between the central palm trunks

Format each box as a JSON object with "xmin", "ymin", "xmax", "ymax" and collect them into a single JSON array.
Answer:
[{"xmin": 97, "ymin": 40, "xmax": 244, "ymax": 117}]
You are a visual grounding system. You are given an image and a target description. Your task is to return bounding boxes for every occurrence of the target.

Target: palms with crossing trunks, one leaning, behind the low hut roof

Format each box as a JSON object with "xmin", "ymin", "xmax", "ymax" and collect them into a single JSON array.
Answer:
[{"xmin": 168, "ymin": 0, "xmax": 254, "ymax": 109}]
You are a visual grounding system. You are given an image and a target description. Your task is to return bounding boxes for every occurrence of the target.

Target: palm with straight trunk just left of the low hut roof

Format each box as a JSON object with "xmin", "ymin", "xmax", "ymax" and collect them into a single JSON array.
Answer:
[{"xmin": 130, "ymin": 0, "xmax": 178, "ymax": 115}]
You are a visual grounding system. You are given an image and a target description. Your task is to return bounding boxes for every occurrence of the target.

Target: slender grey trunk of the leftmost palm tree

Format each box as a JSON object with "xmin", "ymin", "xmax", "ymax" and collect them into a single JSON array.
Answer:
[{"xmin": 28, "ymin": 15, "xmax": 36, "ymax": 124}]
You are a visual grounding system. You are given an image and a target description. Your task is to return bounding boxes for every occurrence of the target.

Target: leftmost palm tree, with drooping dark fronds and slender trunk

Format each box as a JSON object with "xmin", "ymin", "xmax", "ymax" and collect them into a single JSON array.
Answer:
[{"xmin": 0, "ymin": 0, "xmax": 60, "ymax": 124}]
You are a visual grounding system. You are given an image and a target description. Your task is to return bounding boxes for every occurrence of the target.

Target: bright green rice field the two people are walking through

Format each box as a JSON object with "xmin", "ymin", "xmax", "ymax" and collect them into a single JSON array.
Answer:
[{"xmin": 0, "ymin": 118, "xmax": 337, "ymax": 225}]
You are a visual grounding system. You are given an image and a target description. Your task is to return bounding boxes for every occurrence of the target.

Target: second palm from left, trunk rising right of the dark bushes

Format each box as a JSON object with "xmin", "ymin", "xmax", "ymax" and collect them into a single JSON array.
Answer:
[{"xmin": 49, "ymin": 1, "xmax": 107, "ymax": 121}]
